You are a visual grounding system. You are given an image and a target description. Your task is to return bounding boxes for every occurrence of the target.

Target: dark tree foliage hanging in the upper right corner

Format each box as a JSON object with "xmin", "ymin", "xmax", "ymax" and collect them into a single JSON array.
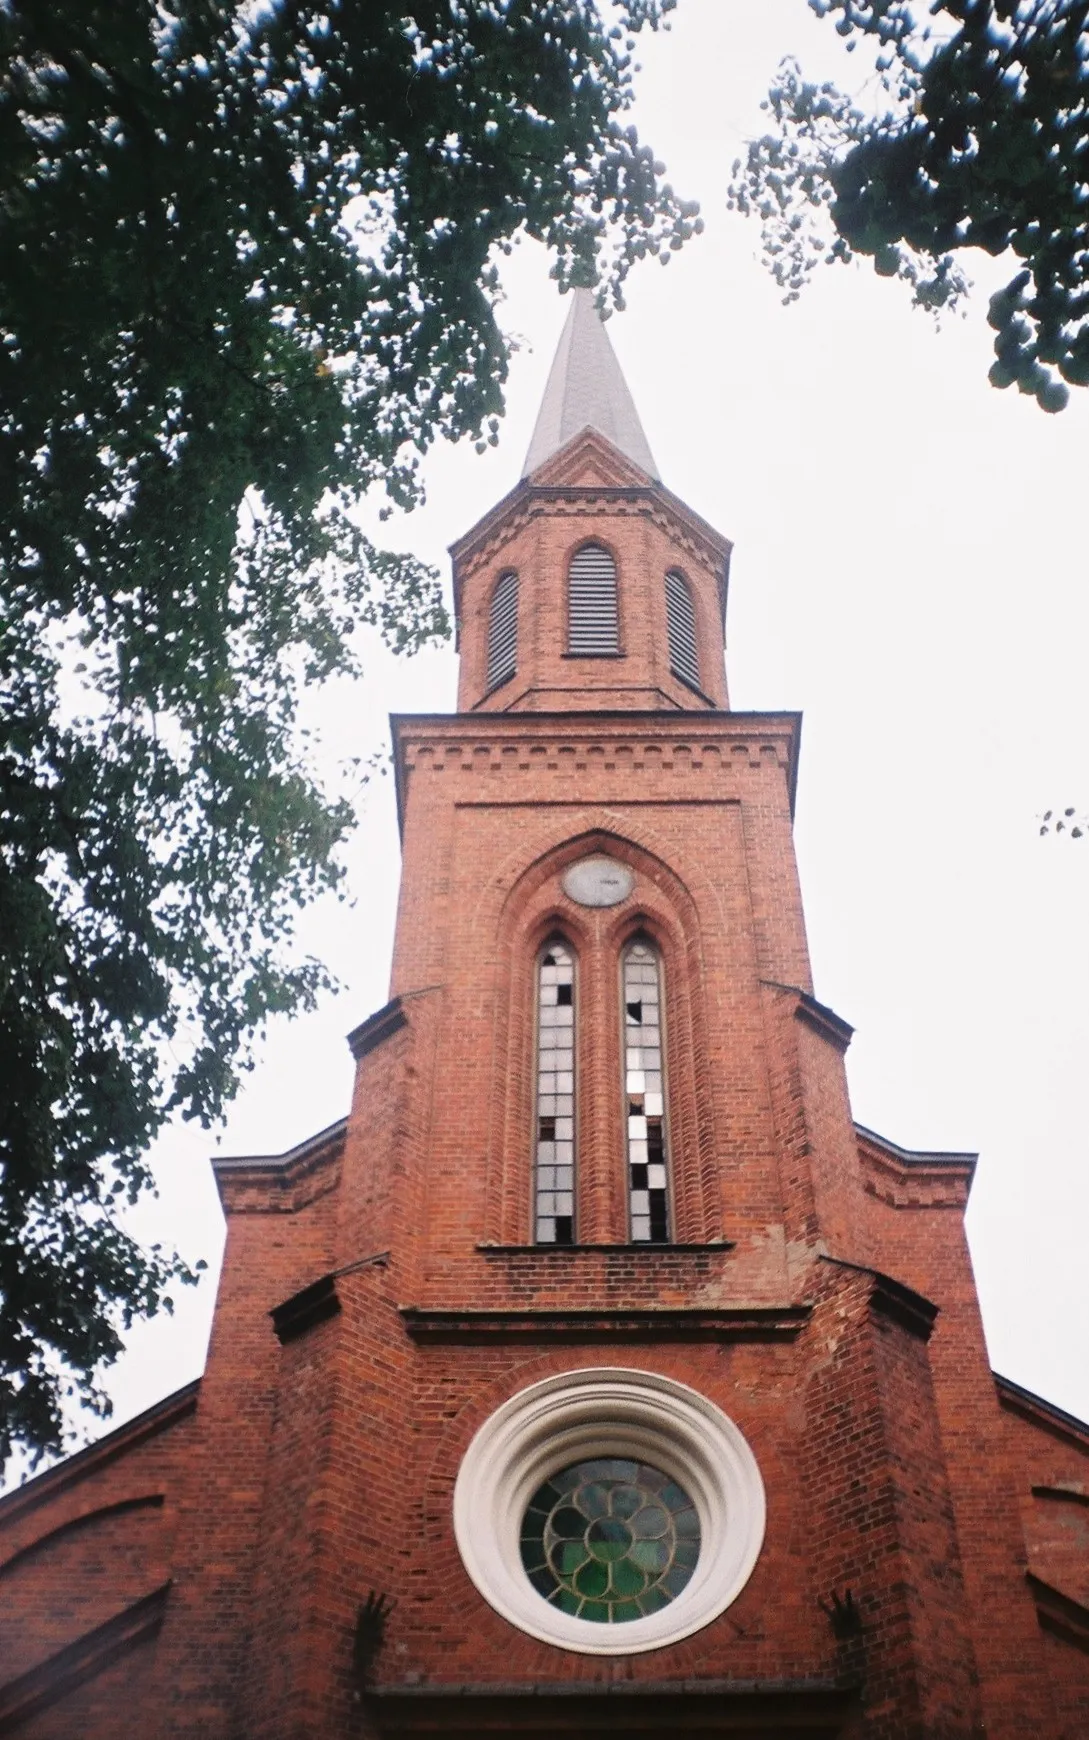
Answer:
[{"xmin": 731, "ymin": 0, "xmax": 1089, "ymax": 411}]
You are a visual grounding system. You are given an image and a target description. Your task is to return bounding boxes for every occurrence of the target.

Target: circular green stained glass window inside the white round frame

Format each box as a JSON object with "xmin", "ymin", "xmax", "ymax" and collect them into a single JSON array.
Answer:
[{"xmin": 520, "ymin": 1456, "xmax": 699, "ymax": 1623}]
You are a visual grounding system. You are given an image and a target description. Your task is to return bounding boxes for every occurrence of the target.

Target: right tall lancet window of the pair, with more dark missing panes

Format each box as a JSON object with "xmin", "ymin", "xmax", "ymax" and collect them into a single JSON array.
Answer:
[{"xmin": 623, "ymin": 936, "xmax": 670, "ymax": 1244}]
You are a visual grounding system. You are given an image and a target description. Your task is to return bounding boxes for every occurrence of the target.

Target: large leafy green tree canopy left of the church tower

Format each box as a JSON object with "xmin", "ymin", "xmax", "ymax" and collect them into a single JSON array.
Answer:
[{"xmin": 0, "ymin": 0, "xmax": 694, "ymax": 1460}]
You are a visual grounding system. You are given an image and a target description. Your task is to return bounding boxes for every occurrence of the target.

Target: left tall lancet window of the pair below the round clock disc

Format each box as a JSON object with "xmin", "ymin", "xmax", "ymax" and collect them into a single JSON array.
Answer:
[{"xmin": 536, "ymin": 940, "xmax": 574, "ymax": 1244}]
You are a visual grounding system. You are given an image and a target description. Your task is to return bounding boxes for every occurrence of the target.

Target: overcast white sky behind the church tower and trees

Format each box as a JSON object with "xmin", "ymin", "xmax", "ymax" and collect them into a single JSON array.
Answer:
[{"xmin": 57, "ymin": 0, "xmax": 1089, "ymax": 1461}]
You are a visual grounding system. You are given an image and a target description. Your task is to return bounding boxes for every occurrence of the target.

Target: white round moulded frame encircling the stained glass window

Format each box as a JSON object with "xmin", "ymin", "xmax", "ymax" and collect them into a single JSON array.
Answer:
[{"xmin": 454, "ymin": 1366, "xmax": 765, "ymax": 1655}]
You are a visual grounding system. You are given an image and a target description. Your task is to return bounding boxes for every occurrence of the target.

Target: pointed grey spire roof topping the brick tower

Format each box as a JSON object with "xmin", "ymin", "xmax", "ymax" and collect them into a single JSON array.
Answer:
[{"xmin": 522, "ymin": 291, "xmax": 658, "ymax": 479}]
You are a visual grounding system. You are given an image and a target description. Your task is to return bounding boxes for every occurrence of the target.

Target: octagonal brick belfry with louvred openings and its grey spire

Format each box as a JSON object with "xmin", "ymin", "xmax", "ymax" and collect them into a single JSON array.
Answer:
[{"xmin": 451, "ymin": 291, "xmax": 731, "ymax": 713}]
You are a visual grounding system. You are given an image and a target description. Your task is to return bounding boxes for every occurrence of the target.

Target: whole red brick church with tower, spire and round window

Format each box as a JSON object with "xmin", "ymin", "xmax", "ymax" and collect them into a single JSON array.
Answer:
[{"xmin": 0, "ymin": 292, "xmax": 1089, "ymax": 1740}]
